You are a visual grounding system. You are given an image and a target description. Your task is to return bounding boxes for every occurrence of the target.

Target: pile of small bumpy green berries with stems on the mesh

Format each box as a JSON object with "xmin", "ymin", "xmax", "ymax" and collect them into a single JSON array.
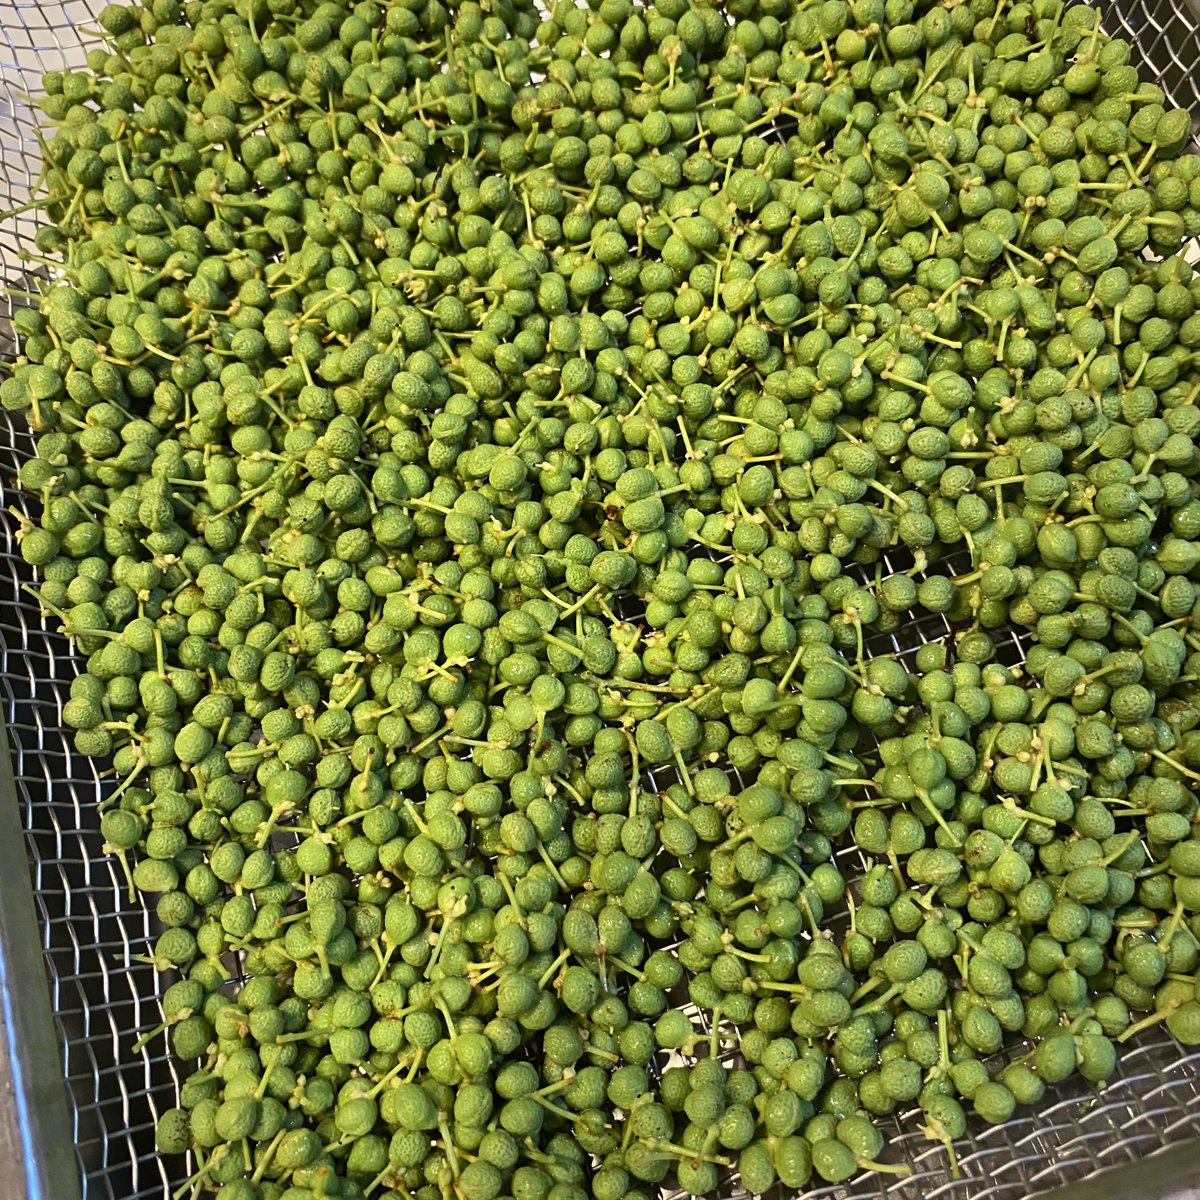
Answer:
[{"xmin": 7, "ymin": 0, "xmax": 1200, "ymax": 1200}]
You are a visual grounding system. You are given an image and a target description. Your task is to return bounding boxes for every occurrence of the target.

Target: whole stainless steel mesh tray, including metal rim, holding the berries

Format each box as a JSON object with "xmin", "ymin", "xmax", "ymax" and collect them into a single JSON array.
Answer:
[{"xmin": 0, "ymin": 0, "xmax": 1200, "ymax": 1200}]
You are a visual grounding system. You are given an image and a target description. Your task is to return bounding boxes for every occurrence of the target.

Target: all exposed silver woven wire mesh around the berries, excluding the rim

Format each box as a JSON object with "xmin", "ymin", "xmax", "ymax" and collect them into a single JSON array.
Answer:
[{"xmin": 0, "ymin": 0, "xmax": 1200, "ymax": 1200}]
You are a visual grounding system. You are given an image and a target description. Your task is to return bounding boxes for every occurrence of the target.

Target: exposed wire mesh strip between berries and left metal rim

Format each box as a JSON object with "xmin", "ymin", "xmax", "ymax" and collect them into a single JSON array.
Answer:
[{"xmin": 0, "ymin": 432, "xmax": 182, "ymax": 1200}]
